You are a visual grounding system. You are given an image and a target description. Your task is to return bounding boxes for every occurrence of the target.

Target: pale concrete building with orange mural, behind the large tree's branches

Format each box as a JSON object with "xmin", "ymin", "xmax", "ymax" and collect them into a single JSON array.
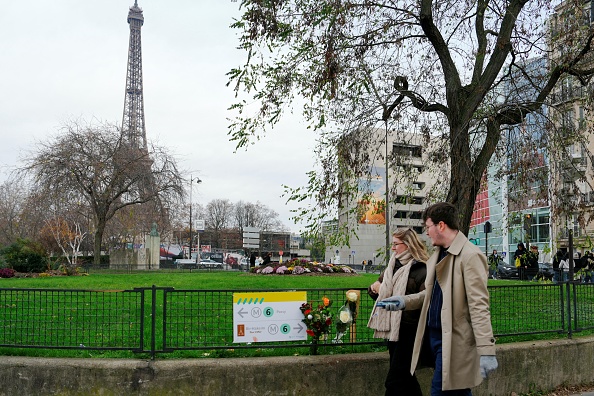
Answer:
[{"xmin": 325, "ymin": 129, "xmax": 435, "ymax": 265}]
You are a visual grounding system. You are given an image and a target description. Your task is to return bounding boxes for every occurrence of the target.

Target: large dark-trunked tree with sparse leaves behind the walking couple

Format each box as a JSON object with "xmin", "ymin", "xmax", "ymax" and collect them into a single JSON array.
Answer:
[{"xmin": 229, "ymin": 0, "xmax": 594, "ymax": 232}]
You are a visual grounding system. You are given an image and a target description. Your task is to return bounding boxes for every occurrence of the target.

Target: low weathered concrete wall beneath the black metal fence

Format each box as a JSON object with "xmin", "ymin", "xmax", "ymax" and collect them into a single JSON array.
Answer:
[{"xmin": 0, "ymin": 337, "xmax": 594, "ymax": 396}]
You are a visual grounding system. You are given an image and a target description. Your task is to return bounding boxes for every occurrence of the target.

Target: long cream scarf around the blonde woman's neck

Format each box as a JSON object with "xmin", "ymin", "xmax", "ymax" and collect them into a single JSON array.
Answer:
[{"xmin": 367, "ymin": 249, "xmax": 415, "ymax": 341}]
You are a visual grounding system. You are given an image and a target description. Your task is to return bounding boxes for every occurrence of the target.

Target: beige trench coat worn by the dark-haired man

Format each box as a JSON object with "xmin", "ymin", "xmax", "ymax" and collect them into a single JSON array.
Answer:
[{"xmin": 404, "ymin": 232, "xmax": 495, "ymax": 390}]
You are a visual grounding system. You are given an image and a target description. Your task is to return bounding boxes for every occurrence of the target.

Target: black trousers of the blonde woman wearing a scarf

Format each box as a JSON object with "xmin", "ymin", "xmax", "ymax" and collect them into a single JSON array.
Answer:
[{"xmin": 385, "ymin": 323, "xmax": 423, "ymax": 396}]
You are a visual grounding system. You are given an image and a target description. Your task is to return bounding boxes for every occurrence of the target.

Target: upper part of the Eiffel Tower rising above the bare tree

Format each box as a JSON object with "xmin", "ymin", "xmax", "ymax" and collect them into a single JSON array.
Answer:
[{"xmin": 122, "ymin": 0, "xmax": 147, "ymax": 152}]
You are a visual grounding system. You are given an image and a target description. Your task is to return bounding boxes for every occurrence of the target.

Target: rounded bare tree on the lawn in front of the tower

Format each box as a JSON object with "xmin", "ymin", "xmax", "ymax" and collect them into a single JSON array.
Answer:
[{"xmin": 22, "ymin": 122, "xmax": 183, "ymax": 264}]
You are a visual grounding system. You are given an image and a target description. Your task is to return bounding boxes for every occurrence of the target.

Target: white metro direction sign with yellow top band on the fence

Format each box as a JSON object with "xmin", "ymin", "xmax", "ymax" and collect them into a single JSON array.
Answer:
[{"xmin": 233, "ymin": 291, "xmax": 307, "ymax": 343}]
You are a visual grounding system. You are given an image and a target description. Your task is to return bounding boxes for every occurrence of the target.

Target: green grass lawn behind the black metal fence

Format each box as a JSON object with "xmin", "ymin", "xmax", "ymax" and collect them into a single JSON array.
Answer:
[{"xmin": 0, "ymin": 270, "xmax": 594, "ymax": 358}]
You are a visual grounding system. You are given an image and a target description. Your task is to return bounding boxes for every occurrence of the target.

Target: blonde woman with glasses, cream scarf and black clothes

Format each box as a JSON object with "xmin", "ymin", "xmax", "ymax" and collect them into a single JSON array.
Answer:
[{"xmin": 367, "ymin": 228, "xmax": 429, "ymax": 396}]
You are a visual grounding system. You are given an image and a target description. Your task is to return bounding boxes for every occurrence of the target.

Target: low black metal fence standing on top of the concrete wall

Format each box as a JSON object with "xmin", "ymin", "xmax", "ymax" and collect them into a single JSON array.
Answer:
[{"xmin": 0, "ymin": 283, "xmax": 594, "ymax": 356}]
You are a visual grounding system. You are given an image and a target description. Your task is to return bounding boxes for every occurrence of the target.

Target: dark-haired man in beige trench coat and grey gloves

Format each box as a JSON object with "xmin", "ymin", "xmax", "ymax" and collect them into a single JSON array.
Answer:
[{"xmin": 383, "ymin": 202, "xmax": 497, "ymax": 396}]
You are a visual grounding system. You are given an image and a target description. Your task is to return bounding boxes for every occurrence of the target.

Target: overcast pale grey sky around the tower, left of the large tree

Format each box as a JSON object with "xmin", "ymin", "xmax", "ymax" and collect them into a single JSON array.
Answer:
[{"xmin": 0, "ymin": 0, "xmax": 314, "ymax": 231}]
